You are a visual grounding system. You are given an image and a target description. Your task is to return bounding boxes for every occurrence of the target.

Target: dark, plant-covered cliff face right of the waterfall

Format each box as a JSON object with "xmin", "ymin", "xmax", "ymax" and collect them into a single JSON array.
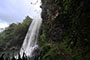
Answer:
[{"xmin": 40, "ymin": 0, "xmax": 90, "ymax": 60}]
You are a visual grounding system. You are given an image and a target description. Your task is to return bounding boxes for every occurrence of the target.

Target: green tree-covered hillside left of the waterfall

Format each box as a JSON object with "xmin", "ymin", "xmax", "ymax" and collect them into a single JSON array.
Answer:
[{"xmin": 0, "ymin": 16, "xmax": 32, "ymax": 50}]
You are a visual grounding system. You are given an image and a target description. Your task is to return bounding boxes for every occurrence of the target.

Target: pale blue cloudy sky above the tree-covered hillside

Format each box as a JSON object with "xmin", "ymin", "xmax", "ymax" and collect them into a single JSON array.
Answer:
[{"xmin": 0, "ymin": 0, "xmax": 41, "ymax": 28}]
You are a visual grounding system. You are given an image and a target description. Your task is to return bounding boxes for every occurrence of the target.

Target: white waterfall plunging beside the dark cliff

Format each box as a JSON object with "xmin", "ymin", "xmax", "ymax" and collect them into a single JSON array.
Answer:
[{"xmin": 20, "ymin": 19, "xmax": 42, "ymax": 57}]
